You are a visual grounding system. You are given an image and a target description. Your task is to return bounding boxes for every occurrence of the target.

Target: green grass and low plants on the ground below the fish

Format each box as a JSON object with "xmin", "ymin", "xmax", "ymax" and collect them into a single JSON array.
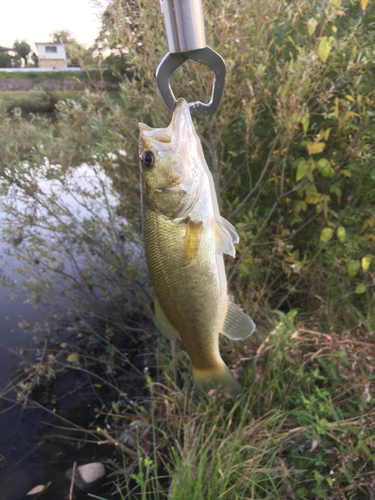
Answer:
[{"xmin": 100, "ymin": 313, "xmax": 375, "ymax": 500}]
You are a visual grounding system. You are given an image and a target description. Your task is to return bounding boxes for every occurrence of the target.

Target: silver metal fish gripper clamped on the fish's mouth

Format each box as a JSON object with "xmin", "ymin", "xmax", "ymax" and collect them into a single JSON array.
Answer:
[{"xmin": 156, "ymin": 0, "xmax": 226, "ymax": 116}]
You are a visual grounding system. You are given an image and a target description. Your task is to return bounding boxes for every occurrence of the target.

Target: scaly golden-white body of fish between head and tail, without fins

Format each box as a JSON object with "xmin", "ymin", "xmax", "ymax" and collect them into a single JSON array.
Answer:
[{"xmin": 143, "ymin": 208, "xmax": 227, "ymax": 369}]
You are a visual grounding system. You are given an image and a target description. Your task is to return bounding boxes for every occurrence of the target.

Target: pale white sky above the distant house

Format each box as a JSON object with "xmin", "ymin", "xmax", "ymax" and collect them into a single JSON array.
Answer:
[{"xmin": 0, "ymin": 0, "xmax": 100, "ymax": 51}]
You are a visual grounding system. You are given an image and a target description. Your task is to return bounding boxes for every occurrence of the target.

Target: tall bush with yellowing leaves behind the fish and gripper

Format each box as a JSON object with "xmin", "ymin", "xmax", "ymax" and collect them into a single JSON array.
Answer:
[{"xmin": 86, "ymin": 0, "xmax": 375, "ymax": 328}]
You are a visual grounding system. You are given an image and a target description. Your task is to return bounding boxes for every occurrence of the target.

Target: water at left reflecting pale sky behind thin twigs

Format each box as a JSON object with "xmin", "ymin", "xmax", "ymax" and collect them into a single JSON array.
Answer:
[{"xmin": 0, "ymin": 162, "xmax": 145, "ymax": 500}]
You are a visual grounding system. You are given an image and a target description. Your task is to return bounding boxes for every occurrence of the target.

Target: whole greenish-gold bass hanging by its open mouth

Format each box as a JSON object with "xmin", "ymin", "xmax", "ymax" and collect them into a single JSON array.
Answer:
[{"xmin": 139, "ymin": 98, "xmax": 255, "ymax": 396}]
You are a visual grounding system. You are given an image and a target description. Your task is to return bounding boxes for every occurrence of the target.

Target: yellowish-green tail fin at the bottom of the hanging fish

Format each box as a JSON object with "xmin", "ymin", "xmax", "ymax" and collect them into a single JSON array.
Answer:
[{"xmin": 193, "ymin": 361, "xmax": 243, "ymax": 397}]
